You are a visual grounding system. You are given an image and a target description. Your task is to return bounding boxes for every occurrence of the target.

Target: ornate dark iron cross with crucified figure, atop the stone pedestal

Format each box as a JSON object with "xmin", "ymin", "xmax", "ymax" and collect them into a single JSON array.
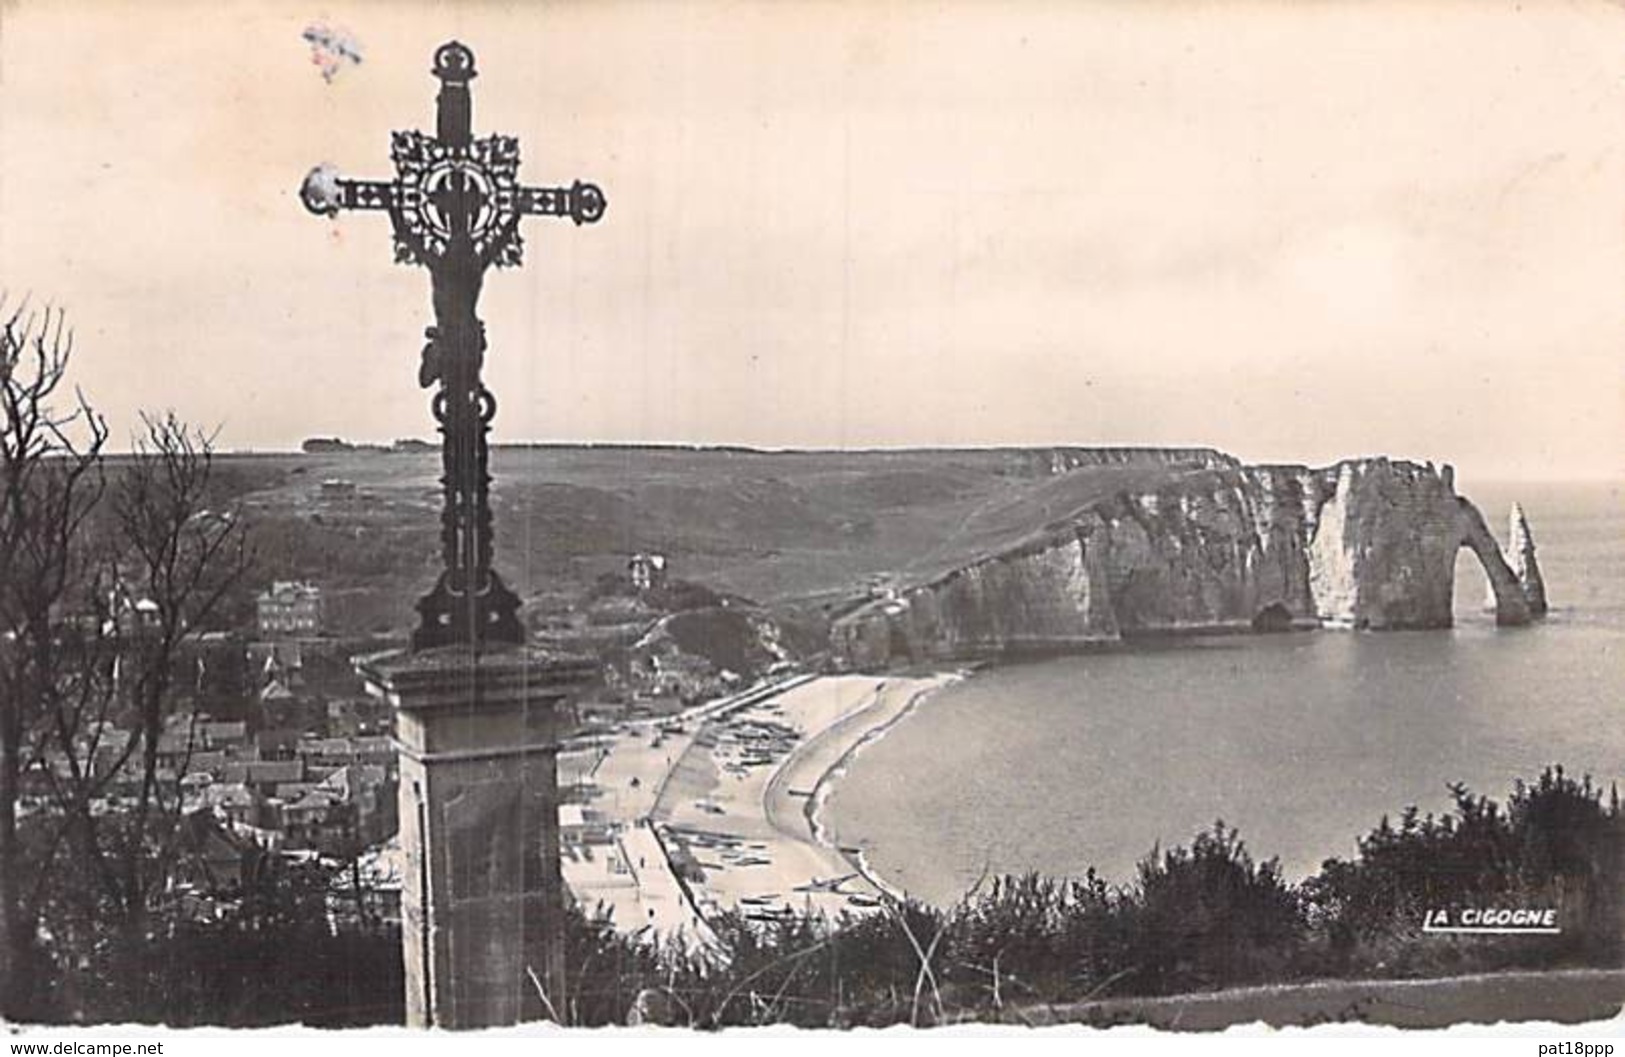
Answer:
[{"xmin": 299, "ymin": 41, "xmax": 605, "ymax": 649}]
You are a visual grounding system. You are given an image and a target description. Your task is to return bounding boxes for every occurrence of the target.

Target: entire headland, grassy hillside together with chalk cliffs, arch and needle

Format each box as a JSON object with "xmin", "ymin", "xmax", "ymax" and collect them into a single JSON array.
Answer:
[{"xmin": 229, "ymin": 446, "xmax": 1545, "ymax": 669}]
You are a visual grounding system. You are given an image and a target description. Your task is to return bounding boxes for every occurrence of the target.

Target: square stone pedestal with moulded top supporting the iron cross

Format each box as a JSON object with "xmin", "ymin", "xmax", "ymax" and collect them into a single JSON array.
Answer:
[{"xmin": 358, "ymin": 646, "xmax": 596, "ymax": 1028}]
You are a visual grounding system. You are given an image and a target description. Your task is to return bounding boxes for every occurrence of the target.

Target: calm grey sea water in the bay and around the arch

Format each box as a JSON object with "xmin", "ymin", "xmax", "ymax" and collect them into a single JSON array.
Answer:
[{"xmin": 824, "ymin": 485, "xmax": 1625, "ymax": 901}]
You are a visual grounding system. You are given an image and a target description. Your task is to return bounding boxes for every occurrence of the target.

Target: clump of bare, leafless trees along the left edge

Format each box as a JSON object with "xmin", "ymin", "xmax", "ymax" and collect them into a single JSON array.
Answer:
[{"xmin": 0, "ymin": 306, "xmax": 250, "ymax": 1018}]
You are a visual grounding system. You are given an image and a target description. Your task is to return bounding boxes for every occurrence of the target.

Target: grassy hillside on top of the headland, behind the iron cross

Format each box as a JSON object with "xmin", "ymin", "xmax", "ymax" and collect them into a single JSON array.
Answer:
[{"xmin": 212, "ymin": 447, "xmax": 1222, "ymax": 631}]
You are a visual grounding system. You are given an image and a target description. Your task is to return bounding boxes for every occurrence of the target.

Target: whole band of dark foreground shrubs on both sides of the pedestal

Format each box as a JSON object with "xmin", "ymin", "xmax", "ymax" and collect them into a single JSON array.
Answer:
[{"xmin": 19, "ymin": 768, "xmax": 1625, "ymax": 1028}]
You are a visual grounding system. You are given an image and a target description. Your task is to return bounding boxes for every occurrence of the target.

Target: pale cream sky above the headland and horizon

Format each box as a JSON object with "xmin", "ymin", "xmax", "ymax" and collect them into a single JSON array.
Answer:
[{"xmin": 0, "ymin": 0, "xmax": 1625, "ymax": 478}]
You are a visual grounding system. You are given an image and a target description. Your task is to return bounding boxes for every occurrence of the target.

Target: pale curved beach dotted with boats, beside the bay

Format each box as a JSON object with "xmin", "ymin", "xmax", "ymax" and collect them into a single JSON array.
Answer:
[{"xmin": 559, "ymin": 673, "xmax": 959, "ymax": 945}]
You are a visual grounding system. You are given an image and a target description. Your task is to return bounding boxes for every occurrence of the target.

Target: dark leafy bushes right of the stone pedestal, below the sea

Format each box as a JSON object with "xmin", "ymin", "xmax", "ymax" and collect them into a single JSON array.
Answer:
[{"xmin": 552, "ymin": 768, "xmax": 1625, "ymax": 1028}]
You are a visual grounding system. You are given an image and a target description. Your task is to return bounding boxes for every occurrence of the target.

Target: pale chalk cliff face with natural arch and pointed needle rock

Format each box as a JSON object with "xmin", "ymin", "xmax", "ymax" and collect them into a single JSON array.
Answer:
[{"xmin": 832, "ymin": 457, "xmax": 1544, "ymax": 665}]
